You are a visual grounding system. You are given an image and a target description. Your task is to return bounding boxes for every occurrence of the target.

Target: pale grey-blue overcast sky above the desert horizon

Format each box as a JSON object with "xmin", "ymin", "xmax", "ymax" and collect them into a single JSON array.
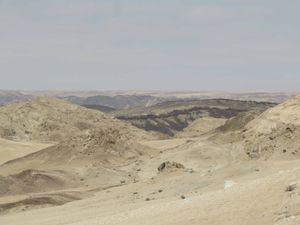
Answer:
[{"xmin": 0, "ymin": 0, "xmax": 300, "ymax": 91}]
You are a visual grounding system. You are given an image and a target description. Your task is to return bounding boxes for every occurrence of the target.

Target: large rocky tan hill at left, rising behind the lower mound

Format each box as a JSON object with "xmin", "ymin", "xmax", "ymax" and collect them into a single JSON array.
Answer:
[{"xmin": 0, "ymin": 97, "xmax": 155, "ymax": 142}]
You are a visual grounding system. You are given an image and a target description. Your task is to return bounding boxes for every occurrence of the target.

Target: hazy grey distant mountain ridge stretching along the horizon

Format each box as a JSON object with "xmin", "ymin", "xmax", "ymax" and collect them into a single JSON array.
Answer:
[{"xmin": 0, "ymin": 90, "xmax": 295, "ymax": 109}]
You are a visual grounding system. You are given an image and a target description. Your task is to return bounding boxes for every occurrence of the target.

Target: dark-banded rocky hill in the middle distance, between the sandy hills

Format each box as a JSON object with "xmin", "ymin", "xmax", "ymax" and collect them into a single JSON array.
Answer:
[{"xmin": 112, "ymin": 99, "xmax": 276, "ymax": 136}]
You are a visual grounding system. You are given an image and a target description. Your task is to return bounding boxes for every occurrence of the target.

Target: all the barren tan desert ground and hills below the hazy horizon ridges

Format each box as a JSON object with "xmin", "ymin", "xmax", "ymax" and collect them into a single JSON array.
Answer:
[{"xmin": 0, "ymin": 93, "xmax": 300, "ymax": 225}]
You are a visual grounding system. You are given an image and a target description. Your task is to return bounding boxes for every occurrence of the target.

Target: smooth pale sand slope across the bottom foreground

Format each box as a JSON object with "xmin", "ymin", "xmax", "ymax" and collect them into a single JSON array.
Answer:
[{"xmin": 0, "ymin": 139, "xmax": 300, "ymax": 225}]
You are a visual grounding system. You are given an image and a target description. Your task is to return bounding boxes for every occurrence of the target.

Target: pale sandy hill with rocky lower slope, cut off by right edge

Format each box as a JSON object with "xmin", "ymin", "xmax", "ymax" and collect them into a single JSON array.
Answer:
[{"xmin": 243, "ymin": 95, "xmax": 300, "ymax": 158}]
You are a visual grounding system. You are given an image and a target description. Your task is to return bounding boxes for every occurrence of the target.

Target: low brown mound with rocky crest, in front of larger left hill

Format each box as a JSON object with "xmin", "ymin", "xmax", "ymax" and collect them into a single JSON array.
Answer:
[{"xmin": 0, "ymin": 128, "xmax": 149, "ymax": 173}]
